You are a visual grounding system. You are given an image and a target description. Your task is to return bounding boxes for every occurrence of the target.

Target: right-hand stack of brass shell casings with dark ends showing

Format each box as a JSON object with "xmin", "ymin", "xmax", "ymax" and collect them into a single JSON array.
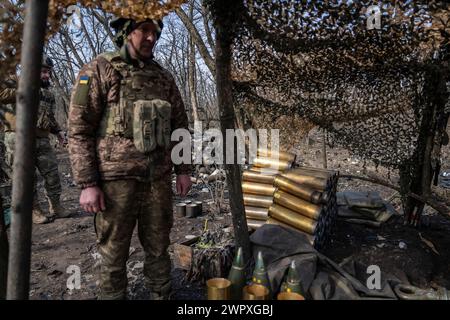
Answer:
[{"xmin": 267, "ymin": 167, "xmax": 339, "ymax": 249}]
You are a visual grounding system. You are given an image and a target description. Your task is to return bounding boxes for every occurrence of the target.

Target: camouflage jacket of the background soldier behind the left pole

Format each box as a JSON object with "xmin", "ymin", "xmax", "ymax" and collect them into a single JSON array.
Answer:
[{"xmin": 0, "ymin": 77, "xmax": 61, "ymax": 136}]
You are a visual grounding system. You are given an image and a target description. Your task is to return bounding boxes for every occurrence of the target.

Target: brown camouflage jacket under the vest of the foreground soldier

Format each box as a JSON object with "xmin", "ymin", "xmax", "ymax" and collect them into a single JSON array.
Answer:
[{"xmin": 68, "ymin": 50, "xmax": 191, "ymax": 188}]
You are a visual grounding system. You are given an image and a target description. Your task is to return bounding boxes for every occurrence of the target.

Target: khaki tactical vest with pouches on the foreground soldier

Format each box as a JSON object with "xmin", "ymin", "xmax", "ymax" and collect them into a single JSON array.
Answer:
[{"xmin": 98, "ymin": 52, "xmax": 172, "ymax": 154}]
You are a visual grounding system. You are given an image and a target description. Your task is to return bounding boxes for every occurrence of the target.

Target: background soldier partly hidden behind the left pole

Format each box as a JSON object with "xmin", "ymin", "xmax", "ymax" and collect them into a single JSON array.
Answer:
[{"xmin": 0, "ymin": 57, "xmax": 68, "ymax": 224}]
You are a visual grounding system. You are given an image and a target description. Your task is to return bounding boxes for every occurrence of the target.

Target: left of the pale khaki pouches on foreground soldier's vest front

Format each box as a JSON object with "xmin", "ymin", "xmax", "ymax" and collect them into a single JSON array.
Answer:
[{"xmin": 133, "ymin": 100, "xmax": 157, "ymax": 154}]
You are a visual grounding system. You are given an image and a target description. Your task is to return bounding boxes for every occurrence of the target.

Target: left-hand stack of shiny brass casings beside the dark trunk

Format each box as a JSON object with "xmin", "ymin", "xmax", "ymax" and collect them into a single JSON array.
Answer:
[{"xmin": 242, "ymin": 149, "xmax": 295, "ymax": 229}]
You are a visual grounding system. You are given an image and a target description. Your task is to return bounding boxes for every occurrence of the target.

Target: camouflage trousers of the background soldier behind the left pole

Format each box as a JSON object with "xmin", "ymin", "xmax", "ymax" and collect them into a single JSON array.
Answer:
[{"xmin": 4, "ymin": 132, "xmax": 61, "ymax": 203}]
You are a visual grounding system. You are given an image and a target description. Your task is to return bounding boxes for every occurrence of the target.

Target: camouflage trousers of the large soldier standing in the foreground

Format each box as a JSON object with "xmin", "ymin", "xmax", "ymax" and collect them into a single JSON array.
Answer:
[{"xmin": 95, "ymin": 177, "xmax": 173, "ymax": 299}]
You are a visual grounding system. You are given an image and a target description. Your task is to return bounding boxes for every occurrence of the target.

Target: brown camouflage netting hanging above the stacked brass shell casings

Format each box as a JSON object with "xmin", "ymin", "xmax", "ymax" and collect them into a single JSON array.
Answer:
[{"xmin": 225, "ymin": 0, "xmax": 450, "ymax": 208}]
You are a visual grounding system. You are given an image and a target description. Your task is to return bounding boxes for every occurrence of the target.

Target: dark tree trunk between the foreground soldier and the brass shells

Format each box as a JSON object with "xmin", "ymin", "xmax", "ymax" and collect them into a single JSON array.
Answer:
[{"xmin": 214, "ymin": 0, "xmax": 251, "ymax": 261}]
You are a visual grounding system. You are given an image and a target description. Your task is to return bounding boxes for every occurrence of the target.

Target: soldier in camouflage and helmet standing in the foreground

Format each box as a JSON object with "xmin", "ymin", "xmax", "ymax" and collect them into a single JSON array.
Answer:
[{"xmin": 68, "ymin": 18, "xmax": 191, "ymax": 299}]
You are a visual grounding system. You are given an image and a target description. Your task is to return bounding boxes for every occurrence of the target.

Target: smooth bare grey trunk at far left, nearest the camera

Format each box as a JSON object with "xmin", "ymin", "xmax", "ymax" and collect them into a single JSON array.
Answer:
[{"xmin": 7, "ymin": 0, "xmax": 48, "ymax": 300}]
